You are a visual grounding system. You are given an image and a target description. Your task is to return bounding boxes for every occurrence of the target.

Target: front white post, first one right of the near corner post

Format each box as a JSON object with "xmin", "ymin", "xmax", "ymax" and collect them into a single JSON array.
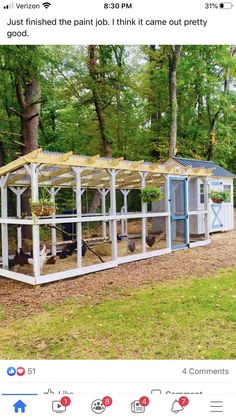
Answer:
[{"xmin": 73, "ymin": 167, "xmax": 84, "ymax": 268}]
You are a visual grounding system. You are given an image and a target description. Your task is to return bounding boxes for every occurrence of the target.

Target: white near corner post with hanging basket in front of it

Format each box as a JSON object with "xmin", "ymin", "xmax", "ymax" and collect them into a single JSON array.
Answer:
[{"xmin": 30, "ymin": 163, "xmax": 40, "ymax": 283}]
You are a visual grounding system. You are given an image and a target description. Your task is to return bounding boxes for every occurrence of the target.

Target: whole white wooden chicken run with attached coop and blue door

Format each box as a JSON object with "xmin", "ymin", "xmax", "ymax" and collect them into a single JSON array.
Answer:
[{"xmin": 0, "ymin": 149, "xmax": 234, "ymax": 285}]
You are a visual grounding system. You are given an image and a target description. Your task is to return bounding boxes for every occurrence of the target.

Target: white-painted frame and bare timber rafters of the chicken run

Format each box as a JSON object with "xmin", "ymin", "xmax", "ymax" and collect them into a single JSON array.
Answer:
[{"xmin": 0, "ymin": 149, "xmax": 214, "ymax": 285}]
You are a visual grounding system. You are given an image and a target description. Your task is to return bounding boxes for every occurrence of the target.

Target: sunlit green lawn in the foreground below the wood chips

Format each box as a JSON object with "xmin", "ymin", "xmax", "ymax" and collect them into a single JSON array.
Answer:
[{"xmin": 0, "ymin": 270, "xmax": 236, "ymax": 359}]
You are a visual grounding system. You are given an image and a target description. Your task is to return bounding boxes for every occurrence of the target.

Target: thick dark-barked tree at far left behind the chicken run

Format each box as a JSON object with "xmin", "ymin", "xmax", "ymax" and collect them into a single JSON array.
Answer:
[{"xmin": 2, "ymin": 46, "xmax": 41, "ymax": 239}]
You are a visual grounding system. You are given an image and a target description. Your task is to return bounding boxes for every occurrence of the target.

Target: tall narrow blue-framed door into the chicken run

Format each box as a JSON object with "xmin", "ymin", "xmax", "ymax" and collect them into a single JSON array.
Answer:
[{"xmin": 170, "ymin": 177, "xmax": 188, "ymax": 249}]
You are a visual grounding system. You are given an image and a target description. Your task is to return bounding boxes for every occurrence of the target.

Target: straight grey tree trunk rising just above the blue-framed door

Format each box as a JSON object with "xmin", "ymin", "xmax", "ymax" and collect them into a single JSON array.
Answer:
[{"xmin": 169, "ymin": 45, "xmax": 182, "ymax": 157}]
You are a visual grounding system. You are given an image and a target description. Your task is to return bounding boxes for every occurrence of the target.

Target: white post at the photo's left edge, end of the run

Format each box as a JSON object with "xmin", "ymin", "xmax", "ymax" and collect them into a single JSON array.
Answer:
[{"xmin": 1, "ymin": 176, "xmax": 9, "ymax": 269}]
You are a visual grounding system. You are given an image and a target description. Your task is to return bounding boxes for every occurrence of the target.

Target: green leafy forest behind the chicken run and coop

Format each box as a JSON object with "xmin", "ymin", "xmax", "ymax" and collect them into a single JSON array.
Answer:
[{"xmin": 0, "ymin": 45, "xmax": 236, "ymax": 207}]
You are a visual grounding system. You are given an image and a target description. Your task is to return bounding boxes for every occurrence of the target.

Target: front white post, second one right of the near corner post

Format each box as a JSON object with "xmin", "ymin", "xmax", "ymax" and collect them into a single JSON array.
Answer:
[{"xmin": 109, "ymin": 169, "xmax": 118, "ymax": 260}]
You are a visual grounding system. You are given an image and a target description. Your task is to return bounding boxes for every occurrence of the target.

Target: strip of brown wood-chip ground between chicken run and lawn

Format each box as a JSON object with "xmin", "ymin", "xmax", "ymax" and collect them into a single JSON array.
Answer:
[{"xmin": 0, "ymin": 212, "xmax": 236, "ymax": 321}]
